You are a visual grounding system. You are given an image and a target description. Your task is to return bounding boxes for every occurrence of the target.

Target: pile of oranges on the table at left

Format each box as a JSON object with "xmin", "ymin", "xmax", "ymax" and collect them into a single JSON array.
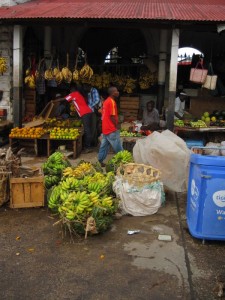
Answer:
[{"xmin": 9, "ymin": 127, "xmax": 46, "ymax": 139}]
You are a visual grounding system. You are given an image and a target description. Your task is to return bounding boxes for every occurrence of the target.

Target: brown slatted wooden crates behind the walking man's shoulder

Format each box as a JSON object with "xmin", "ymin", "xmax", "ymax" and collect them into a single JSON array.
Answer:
[{"xmin": 119, "ymin": 97, "xmax": 140, "ymax": 122}]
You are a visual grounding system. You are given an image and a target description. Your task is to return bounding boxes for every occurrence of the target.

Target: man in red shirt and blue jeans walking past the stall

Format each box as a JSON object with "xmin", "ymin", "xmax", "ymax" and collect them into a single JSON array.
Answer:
[{"xmin": 98, "ymin": 86, "xmax": 123, "ymax": 166}]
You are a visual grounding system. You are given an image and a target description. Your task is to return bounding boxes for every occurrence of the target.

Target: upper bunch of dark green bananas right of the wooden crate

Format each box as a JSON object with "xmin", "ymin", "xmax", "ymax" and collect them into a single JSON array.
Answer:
[{"xmin": 42, "ymin": 152, "xmax": 70, "ymax": 178}]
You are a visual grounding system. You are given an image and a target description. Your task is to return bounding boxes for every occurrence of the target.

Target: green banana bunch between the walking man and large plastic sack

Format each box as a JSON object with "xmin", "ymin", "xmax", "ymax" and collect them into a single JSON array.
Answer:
[{"xmin": 106, "ymin": 150, "xmax": 134, "ymax": 172}]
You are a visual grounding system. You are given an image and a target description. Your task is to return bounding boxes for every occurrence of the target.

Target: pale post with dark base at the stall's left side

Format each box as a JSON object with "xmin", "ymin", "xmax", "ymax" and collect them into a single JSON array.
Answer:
[{"xmin": 13, "ymin": 25, "xmax": 23, "ymax": 127}]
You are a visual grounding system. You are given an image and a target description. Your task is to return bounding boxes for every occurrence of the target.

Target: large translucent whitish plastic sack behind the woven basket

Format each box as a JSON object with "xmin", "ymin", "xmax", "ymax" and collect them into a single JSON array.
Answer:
[{"xmin": 133, "ymin": 130, "xmax": 191, "ymax": 192}]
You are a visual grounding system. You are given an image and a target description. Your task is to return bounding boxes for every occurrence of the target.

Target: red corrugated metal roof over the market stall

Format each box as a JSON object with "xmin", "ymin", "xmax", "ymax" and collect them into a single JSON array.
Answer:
[{"xmin": 0, "ymin": 0, "xmax": 225, "ymax": 22}]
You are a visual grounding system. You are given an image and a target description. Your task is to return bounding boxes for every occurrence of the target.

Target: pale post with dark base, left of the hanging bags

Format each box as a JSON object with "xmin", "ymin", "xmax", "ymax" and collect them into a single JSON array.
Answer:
[{"xmin": 167, "ymin": 29, "xmax": 180, "ymax": 131}]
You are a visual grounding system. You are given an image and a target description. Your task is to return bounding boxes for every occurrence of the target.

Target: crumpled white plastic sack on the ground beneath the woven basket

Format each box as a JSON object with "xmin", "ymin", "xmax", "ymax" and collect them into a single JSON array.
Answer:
[{"xmin": 113, "ymin": 176, "xmax": 165, "ymax": 216}]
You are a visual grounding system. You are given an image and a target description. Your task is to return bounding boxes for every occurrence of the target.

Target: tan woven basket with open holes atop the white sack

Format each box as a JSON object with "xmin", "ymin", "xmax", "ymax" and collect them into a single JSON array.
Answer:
[{"xmin": 117, "ymin": 163, "xmax": 161, "ymax": 186}]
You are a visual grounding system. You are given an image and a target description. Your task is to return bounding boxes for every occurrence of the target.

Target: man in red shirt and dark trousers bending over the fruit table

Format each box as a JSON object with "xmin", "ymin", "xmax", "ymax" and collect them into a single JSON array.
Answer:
[{"xmin": 65, "ymin": 87, "xmax": 93, "ymax": 153}]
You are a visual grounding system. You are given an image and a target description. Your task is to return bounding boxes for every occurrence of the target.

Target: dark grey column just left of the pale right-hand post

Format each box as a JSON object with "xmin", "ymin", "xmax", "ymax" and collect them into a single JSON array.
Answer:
[{"xmin": 157, "ymin": 29, "xmax": 167, "ymax": 114}]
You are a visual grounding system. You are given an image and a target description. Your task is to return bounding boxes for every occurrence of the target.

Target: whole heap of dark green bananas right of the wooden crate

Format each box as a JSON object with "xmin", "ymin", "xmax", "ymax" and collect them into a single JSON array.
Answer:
[{"xmin": 42, "ymin": 152, "xmax": 70, "ymax": 189}]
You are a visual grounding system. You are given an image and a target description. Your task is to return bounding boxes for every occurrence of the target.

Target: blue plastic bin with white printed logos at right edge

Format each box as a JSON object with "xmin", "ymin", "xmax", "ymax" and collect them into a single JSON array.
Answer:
[{"xmin": 186, "ymin": 154, "xmax": 225, "ymax": 240}]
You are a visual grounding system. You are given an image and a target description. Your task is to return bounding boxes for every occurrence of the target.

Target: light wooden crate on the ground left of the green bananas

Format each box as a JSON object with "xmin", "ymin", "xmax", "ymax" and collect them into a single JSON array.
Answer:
[{"xmin": 10, "ymin": 176, "xmax": 45, "ymax": 208}]
